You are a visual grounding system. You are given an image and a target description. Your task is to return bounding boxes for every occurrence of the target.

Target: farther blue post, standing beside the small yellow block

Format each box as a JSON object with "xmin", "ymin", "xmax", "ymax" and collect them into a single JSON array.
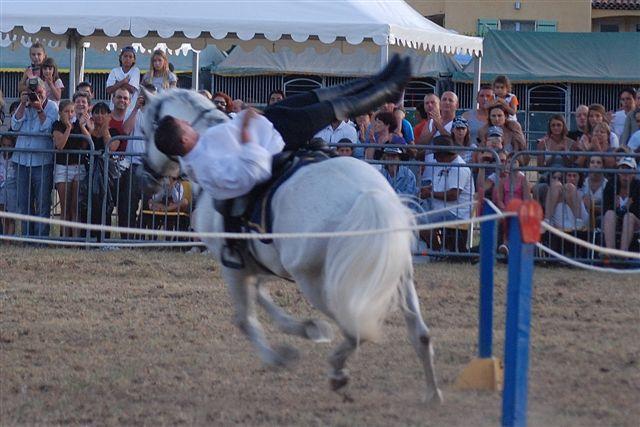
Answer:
[{"xmin": 478, "ymin": 202, "xmax": 497, "ymax": 359}]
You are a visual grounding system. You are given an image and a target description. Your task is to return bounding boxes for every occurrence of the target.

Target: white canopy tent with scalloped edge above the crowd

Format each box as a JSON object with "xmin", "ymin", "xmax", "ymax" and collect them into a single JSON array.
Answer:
[{"xmin": 0, "ymin": 0, "xmax": 482, "ymax": 93}]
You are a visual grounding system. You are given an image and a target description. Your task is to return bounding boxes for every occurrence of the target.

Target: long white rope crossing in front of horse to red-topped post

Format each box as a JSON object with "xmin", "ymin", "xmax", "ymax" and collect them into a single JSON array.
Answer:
[{"xmin": 0, "ymin": 211, "xmax": 515, "ymax": 240}]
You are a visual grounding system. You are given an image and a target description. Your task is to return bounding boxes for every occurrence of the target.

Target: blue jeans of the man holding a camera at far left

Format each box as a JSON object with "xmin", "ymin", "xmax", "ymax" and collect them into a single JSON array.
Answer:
[{"xmin": 16, "ymin": 164, "xmax": 53, "ymax": 237}]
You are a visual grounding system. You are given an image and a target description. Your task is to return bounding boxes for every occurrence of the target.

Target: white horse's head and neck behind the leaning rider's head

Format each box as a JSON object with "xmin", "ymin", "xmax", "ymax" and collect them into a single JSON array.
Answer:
[{"xmin": 139, "ymin": 88, "xmax": 228, "ymax": 191}]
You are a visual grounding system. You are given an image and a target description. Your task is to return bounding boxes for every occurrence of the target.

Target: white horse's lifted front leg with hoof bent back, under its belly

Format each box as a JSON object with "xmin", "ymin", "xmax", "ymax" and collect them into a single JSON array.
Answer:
[{"xmin": 258, "ymin": 284, "xmax": 333, "ymax": 342}]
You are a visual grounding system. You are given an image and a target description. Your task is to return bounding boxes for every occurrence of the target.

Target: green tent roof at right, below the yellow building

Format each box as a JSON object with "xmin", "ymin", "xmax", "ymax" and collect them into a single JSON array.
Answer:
[{"xmin": 454, "ymin": 31, "xmax": 640, "ymax": 84}]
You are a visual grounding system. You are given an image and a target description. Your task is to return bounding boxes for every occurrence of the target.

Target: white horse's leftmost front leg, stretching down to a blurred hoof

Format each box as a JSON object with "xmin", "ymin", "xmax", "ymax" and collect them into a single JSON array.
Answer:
[{"xmin": 223, "ymin": 268, "xmax": 298, "ymax": 366}]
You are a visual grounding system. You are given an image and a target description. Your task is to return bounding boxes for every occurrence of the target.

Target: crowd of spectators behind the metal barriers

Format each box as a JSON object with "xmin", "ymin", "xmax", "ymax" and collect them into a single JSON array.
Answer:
[{"xmin": 0, "ymin": 43, "xmax": 640, "ymax": 260}]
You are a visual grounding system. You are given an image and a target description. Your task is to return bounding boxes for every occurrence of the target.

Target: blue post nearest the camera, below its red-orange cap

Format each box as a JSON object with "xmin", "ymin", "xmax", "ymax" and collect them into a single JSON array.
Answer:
[{"xmin": 502, "ymin": 217, "xmax": 534, "ymax": 427}]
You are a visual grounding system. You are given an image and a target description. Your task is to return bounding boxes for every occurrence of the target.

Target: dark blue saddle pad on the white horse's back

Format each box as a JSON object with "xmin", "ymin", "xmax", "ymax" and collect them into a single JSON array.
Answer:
[{"xmin": 246, "ymin": 151, "xmax": 331, "ymax": 244}]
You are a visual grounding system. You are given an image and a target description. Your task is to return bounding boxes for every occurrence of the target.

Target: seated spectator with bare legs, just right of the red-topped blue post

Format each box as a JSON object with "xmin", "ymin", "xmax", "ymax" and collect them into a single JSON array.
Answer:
[{"xmin": 544, "ymin": 166, "xmax": 589, "ymax": 230}]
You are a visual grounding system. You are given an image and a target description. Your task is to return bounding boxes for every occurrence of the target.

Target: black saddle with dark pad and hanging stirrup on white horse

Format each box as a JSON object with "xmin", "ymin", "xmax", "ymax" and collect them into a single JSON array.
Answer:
[{"xmin": 214, "ymin": 147, "xmax": 336, "ymax": 269}]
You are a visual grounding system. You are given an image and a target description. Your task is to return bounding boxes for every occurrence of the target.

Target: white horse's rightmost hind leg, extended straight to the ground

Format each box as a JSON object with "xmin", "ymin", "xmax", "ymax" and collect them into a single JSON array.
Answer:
[{"xmin": 403, "ymin": 279, "xmax": 442, "ymax": 403}]
